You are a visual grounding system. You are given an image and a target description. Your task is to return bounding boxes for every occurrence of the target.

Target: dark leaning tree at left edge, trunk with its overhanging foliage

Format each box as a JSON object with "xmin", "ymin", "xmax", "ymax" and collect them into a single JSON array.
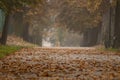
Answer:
[{"xmin": 0, "ymin": 0, "xmax": 41, "ymax": 45}]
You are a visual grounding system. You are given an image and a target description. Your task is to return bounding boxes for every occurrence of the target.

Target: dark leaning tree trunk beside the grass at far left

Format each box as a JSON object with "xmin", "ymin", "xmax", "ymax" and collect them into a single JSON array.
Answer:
[{"xmin": 0, "ymin": 13, "xmax": 10, "ymax": 45}]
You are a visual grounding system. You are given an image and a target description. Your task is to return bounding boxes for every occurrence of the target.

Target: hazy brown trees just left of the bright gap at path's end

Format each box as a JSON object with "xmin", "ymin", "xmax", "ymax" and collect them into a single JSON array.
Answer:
[{"xmin": 23, "ymin": 2, "xmax": 49, "ymax": 46}]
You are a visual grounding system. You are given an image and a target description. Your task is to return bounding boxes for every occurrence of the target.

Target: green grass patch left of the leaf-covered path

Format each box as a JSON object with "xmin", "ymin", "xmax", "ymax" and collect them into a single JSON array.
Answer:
[{"xmin": 0, "ymin": 45, "xmax": 22, "ymax": 58}]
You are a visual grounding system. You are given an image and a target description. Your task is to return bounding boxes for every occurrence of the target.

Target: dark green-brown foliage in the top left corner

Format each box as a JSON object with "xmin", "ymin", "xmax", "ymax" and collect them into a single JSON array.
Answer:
[{"xmin": 0, "ymin": 0, "xmax": 42, "ymax": 13}]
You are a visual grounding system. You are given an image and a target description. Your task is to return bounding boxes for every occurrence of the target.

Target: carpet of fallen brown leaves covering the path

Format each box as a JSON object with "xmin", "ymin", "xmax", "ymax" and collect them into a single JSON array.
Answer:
[{"xmin": 0, "ymin": 48, "xmax": 120, "ymax": 80}]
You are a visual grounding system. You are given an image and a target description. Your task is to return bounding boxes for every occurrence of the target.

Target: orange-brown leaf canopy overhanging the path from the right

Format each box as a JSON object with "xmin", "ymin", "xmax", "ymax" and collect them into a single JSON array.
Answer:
[{"xmin": 52, "ymin": 0, "xmax": 115, "ymax": 31}]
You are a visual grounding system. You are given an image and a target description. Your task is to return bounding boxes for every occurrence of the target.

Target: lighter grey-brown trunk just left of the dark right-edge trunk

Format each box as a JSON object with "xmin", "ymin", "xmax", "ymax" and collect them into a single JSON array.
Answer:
[{"xmin": 102, "ymin": 7, "xmax": 111, "ymax": 48}]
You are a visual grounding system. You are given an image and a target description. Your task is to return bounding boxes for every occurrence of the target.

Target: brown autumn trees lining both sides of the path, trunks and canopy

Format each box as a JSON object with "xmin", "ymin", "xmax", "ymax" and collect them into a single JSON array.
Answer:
[{"xmin": 0, "ymin": 0, "xmax": 120, "ymax": 48}]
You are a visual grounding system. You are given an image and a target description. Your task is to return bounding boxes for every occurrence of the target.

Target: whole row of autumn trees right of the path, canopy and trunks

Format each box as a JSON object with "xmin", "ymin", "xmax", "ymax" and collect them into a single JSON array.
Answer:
[{"xmin": 47, "ymin": 0, "xmax": 120, "ymax": 48}]
